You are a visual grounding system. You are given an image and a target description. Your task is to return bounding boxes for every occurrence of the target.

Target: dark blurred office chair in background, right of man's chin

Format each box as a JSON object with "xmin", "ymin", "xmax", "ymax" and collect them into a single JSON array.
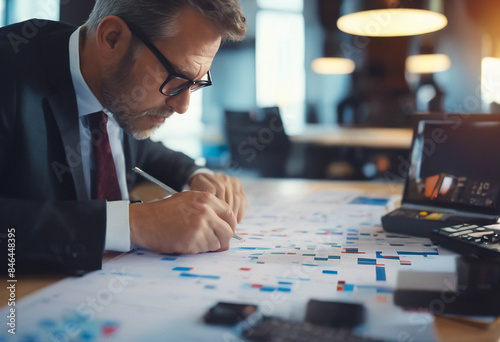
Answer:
[{"xmin": 225, "ymin": 107, "xmax": 291, "ymax": 177}]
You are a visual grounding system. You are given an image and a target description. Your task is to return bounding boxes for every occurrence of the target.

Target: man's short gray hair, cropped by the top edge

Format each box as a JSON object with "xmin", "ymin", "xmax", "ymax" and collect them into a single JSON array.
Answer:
[{"xmin": 85, "ymin": 0, "xmax": 246, "ymax": 41}]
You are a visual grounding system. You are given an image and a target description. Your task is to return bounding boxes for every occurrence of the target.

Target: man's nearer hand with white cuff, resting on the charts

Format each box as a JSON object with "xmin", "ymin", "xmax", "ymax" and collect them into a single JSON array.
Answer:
[{"xmin": 129, "ymin": 191, "xmax": 236, "ymax": 254}]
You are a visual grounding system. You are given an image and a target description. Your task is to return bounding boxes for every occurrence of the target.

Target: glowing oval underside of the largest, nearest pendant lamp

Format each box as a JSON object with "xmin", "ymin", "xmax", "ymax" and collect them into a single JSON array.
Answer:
[{"xmin": 337, "ymin": 8, "xmax": 448, "ymax": 37}]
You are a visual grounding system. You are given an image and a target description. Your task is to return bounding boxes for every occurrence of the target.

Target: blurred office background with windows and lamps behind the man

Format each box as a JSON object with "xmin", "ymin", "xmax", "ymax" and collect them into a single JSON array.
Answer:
[{"xmin": 0, "ymin": 0, "xmax": 500, "ymax": 180}]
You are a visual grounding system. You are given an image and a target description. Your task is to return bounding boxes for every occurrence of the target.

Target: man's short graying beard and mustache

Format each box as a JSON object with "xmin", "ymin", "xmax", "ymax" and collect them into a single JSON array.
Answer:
[{"xmin": 101, "ymin": 44, "xmax": 174, "ymax": 140}]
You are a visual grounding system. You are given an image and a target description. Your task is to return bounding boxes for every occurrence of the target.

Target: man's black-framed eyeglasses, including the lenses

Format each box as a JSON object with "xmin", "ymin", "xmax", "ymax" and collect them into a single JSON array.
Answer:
[{"xmin": 125, "ymin": 22, "xmax": 212, "ymax": 96}]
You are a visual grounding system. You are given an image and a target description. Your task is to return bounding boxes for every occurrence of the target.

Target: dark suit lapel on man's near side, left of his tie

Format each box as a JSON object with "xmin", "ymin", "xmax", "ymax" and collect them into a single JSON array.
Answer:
[{"xmin": 42, "ymin": 28, "xmax": 88, "ymax": 200}]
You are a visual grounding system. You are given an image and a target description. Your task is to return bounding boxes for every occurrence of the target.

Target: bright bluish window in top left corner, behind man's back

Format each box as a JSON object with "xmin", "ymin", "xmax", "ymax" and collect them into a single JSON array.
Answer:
[{"xmin": 0, "ymin": 0, "xmax": 60, "ymax": 25}]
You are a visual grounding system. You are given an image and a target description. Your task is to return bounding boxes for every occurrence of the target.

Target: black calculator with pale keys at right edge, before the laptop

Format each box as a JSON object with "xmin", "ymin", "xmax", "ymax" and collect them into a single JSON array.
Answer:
[{"xmin": 431, "ymin": 223, "xmax": 500, "ymax": 258}]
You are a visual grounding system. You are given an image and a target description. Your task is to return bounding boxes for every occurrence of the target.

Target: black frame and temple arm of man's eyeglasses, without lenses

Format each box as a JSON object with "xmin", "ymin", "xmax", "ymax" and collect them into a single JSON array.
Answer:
[{"xmin": 122, "ymin": 19, "xmax": 213, "ymax": 97}]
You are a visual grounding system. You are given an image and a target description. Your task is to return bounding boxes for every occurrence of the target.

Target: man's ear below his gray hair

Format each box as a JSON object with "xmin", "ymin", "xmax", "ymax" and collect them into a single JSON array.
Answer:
[{"xmin": 96, "ymin": 16, "xmax": 132, "ymax": 62}]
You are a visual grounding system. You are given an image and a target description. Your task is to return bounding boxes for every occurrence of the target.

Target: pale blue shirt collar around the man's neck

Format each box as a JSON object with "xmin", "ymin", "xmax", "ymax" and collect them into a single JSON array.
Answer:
[{"xmin": 69, "ymin": 27, "xmax": 104, "ymax": 117}]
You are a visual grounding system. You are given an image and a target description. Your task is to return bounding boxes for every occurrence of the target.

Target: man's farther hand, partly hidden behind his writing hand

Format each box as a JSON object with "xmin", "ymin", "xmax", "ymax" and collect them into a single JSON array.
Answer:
[{"xmin": 189, "ymin": 173, "xmax": 247, "ymax": 223}]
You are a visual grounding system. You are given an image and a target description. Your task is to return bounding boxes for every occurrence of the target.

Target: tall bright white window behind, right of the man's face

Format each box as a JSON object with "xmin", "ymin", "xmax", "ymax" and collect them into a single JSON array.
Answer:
[{"xmin": 256, "ymin": 0, "xmax": 305, "ymax": 132}]
